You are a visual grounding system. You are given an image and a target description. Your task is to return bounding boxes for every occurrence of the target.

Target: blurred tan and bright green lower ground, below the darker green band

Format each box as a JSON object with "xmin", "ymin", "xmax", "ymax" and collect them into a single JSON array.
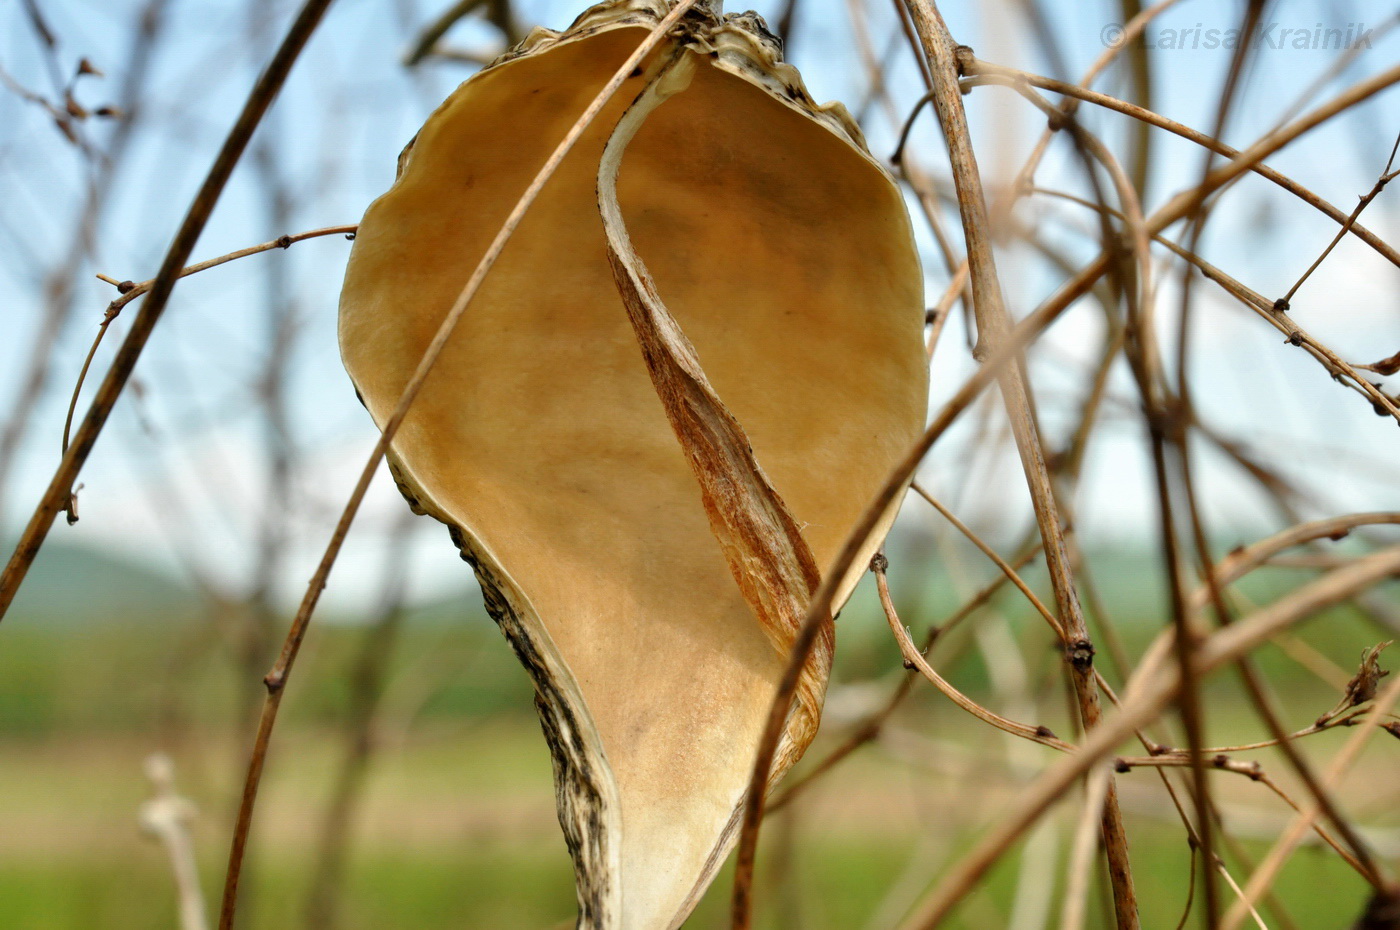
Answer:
[{"xmin": 0, "ymin": 719, "xmax": 1365, "ymax": 930}]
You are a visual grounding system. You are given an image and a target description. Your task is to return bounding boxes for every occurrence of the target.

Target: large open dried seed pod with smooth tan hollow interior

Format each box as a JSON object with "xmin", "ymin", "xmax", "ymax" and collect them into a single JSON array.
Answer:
[{"xmin": 340, "ymin": 0, "xmax": 927, "ymax": 930}]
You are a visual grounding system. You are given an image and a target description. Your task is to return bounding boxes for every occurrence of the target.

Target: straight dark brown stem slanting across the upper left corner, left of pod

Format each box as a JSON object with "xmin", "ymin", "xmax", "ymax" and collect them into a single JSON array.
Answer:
[{"xmin": 0, "ymin": 0, "xmax": 333, "ymax": 619}]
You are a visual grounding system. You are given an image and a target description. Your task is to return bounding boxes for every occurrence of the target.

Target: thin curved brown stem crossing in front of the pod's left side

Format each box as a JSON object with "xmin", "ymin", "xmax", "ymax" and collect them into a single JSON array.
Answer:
[{"xmin": 218, "ymin": 0, "xmax": 697, "ymax": 930}]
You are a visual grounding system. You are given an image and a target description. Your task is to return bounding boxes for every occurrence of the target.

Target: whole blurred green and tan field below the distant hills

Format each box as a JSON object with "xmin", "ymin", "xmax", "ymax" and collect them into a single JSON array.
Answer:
[{"xmin": 0, "ymin": 540, "xmax": 1400, "ymax": 930}]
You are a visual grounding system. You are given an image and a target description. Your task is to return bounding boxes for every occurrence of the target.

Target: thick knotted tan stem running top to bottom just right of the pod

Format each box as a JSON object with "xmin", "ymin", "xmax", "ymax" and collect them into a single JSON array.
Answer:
[{"xmin": 907, "ymin": 0, "xmax": 1138, "ymax": 930}]
